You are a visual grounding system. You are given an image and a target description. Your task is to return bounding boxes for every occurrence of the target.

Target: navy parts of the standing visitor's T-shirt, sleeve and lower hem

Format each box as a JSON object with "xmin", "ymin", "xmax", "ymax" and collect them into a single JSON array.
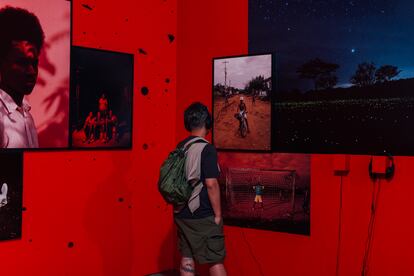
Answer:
[{"xmin": 175, "ymin": 136, "xmax": 220, "ymax": 219}]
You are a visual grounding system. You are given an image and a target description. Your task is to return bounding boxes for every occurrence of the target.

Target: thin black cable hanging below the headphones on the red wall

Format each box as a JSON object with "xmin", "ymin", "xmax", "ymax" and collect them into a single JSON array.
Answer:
[{"xmin": 361, "ymin": 179, "xmax": 381, "ymax": 276}]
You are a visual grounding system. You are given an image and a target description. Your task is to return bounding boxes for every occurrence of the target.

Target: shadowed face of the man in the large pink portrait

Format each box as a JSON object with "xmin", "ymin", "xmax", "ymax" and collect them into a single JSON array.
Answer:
[{"xmin": 0, "ymin": 41, "xmax": 39, "ymax": 96}]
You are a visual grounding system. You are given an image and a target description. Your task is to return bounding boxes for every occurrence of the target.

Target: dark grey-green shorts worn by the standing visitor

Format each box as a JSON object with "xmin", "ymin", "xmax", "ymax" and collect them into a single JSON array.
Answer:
[{"xmin": 175, "ymin": 216, "xmax": 226, "ymax": 264}]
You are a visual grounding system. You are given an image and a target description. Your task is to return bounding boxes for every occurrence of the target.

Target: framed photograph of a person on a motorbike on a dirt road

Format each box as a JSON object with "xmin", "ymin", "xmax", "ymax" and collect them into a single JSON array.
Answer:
[{"xmin": 213, "ymin": 54, "xmax": 272, "ymax": 152}]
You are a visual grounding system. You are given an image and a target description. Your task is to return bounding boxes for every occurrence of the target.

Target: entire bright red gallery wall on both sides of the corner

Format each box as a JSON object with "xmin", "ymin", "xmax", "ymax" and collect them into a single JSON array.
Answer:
[{"xmin": 0, "ymin": 0, "xmax": 414, "ymax": 276}]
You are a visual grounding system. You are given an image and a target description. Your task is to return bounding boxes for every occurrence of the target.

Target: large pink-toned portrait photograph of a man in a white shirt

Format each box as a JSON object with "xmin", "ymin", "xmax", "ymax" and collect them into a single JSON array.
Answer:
[{"xmin": 0, "ymin": 0, "xmax": 71, "ymax": 149}]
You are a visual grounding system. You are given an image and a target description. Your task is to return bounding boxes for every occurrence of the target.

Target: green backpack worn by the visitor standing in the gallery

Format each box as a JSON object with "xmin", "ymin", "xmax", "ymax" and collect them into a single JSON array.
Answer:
[{"xmin": 158, "ymin": 138, "xmax": 203, "ymax": 206}]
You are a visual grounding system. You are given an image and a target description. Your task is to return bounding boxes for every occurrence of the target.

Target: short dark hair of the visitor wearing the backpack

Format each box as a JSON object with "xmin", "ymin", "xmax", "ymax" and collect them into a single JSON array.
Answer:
[{"xmin": 184, "ymin": 102, "xmax": 213, "ymax": 131}]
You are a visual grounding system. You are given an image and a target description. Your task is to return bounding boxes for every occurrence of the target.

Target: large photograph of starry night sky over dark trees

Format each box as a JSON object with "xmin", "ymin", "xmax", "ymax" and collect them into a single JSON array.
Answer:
[{"xmin": 249, "ymin": 0, "xmax": 414, "ymax": 155}]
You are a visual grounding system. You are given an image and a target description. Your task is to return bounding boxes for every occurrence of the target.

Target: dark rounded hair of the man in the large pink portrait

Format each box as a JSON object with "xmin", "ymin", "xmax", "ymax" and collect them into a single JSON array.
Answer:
[{"xmin": 0, "ymin": 6, "xmax": 45, "ymax": 61}]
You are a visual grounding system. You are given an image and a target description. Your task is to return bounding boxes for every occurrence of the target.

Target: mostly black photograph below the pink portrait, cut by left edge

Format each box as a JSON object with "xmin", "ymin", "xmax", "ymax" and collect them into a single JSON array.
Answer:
[{"xmin": 0, "ymin": 152, "xmax": 23, "ymax": 241}]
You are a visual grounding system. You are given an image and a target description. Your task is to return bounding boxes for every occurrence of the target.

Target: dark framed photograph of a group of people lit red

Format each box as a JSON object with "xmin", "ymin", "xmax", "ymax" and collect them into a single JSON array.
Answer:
[{"xmin": 70, "ymin": 46, "xmax": 134, "ymax": 149}]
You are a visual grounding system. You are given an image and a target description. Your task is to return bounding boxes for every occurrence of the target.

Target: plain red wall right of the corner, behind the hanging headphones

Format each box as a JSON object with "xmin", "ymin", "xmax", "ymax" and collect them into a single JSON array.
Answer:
[{"xmin": 176, "ymin": 0, "xmax": 414, "ymax": 276}]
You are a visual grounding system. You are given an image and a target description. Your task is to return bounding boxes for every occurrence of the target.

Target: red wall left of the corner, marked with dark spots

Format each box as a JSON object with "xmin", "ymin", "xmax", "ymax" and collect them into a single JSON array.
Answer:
[{"xmin": 0, "ymin": 0, "xmax": 177, "ymax": 276}]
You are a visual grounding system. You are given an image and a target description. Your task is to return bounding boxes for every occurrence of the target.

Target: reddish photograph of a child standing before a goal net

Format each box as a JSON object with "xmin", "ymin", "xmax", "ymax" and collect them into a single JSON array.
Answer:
[{"xmin": 219, "ymin": 152, "xmax": 311, "ymax": 235}]
